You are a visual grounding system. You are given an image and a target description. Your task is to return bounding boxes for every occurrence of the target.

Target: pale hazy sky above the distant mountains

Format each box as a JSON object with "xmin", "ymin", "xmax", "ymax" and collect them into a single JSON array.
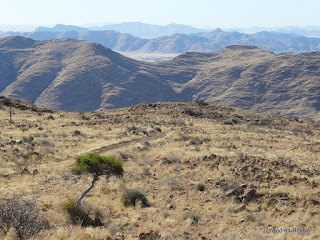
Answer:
[{"xmin": 0, "ymin": 0, "xmax": 320, "ymax": 28}]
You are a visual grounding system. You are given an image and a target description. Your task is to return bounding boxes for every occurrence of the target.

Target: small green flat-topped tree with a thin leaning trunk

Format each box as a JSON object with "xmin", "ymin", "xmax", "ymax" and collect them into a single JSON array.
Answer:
[{"xmin": 76, "ymin": 153, "xmax": 123, "ymax": 206}]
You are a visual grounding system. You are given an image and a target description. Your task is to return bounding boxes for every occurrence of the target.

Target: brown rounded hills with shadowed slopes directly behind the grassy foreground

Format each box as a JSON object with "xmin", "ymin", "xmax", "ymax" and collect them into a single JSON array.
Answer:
[{"xmin": 0, "ymin": 37, "xmax": 320, "ymax": 119}]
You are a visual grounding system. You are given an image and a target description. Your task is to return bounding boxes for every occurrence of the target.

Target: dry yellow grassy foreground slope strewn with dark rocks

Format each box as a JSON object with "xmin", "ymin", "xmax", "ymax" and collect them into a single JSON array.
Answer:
[{"xmin": 0, "ymin": 97, "xmax": 320, "ymax": 240}]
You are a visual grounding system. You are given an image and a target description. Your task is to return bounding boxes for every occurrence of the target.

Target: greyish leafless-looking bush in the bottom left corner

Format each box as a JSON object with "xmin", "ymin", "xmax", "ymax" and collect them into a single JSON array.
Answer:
[{"xmin": 0, "ymin": 197, "xmax": 50, "ymax": 239}]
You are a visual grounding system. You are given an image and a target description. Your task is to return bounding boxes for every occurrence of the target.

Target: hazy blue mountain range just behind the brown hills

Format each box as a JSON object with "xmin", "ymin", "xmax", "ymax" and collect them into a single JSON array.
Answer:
[{"xmin": 0, "ymin": 25, "xmax": 320, "ymax": 56}]
